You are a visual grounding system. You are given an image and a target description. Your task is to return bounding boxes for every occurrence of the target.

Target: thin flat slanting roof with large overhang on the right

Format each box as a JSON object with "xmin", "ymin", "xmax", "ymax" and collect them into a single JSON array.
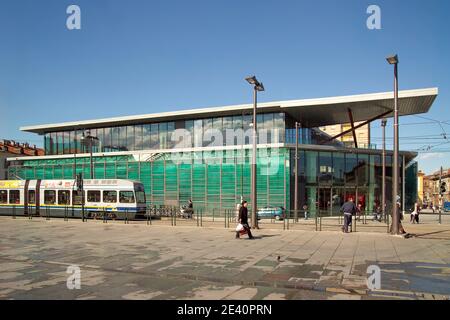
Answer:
[{"xmin": 20, "ymin": 88, "xmax": 438, "ymax": 134}]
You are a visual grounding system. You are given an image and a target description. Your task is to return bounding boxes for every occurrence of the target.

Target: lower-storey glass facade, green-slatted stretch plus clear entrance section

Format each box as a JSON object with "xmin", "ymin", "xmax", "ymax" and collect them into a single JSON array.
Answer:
[{"xmin": 8, "ymin": 145, "xmax": 417, "ymax": 216}]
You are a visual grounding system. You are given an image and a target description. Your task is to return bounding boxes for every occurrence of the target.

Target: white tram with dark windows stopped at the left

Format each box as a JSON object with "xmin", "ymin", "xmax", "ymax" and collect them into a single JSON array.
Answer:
[{"xmin": 0, "ymin": 179, "xmax": 146, "ymax": 219}]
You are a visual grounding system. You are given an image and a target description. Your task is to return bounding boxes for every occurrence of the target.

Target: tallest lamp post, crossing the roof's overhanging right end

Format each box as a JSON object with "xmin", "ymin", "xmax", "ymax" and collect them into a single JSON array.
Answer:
[{"xmin": 386, "ymin": 55, "xmax": 400, "ymax": 234}]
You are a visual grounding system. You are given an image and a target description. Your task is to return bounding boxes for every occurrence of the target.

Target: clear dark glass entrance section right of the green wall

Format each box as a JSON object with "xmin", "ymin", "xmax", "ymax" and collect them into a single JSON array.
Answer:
[{"xmin": 291, "ymin": 150, "xmax": 402, "ymax": 216}]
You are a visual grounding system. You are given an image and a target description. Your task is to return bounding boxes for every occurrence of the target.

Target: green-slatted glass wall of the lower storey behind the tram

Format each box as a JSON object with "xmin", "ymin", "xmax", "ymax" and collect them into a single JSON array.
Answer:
[{"xmin": 9, "ymin": 148, "xmax": 290, "ymax": 214}]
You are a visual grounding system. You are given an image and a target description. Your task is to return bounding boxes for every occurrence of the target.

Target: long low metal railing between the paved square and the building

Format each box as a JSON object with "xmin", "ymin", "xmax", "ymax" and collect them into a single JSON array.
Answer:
[{"xmin": 5, "ymin": 205, "xmax": 450, "ymax": 232}]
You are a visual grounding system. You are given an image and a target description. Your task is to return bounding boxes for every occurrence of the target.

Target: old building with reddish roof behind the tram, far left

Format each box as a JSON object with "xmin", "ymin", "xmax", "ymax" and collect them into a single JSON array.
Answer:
[{"xmin": 0, "ymin": 139, "xmax": 45, "ymax": 180}]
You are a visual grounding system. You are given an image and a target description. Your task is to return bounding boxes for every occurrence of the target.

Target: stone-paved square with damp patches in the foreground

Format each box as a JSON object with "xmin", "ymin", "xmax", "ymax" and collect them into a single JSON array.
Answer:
[{"xmin": 0, "ymin": 217, "xmax": 450, "ymax": 300}]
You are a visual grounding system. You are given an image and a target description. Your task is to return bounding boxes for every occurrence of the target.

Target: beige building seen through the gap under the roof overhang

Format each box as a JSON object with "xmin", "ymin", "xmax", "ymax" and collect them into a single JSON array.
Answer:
[{"xmin": 319, "ymin": 122, "xmax": 376, "ymax": 149}]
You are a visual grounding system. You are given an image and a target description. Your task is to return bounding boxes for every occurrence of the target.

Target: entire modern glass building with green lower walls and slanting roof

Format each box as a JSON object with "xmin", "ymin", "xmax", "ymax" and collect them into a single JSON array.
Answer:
[{"xmin": 8, "ymin": 88, "xmax": 438, "ymax": 215}]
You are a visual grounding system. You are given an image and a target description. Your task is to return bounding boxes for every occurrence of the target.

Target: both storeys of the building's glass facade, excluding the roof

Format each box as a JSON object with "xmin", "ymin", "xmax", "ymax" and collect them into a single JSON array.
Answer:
[{"xmin": 9, "ymin": 113, "xmax": 417, "ymax": 216}]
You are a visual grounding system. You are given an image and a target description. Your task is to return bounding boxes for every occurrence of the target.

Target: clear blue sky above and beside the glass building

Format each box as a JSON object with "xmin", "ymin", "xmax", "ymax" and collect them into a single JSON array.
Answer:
[{"xmin": 0, "ymin": 0, "xmax": 450, "ymax": 172}]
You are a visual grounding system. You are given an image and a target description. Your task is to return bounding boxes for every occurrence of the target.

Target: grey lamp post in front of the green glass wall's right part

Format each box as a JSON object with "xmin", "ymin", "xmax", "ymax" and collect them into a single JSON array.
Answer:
[{"xmin": 245, "ymin": 76, "xmax": 264, "ymax": 229}]
